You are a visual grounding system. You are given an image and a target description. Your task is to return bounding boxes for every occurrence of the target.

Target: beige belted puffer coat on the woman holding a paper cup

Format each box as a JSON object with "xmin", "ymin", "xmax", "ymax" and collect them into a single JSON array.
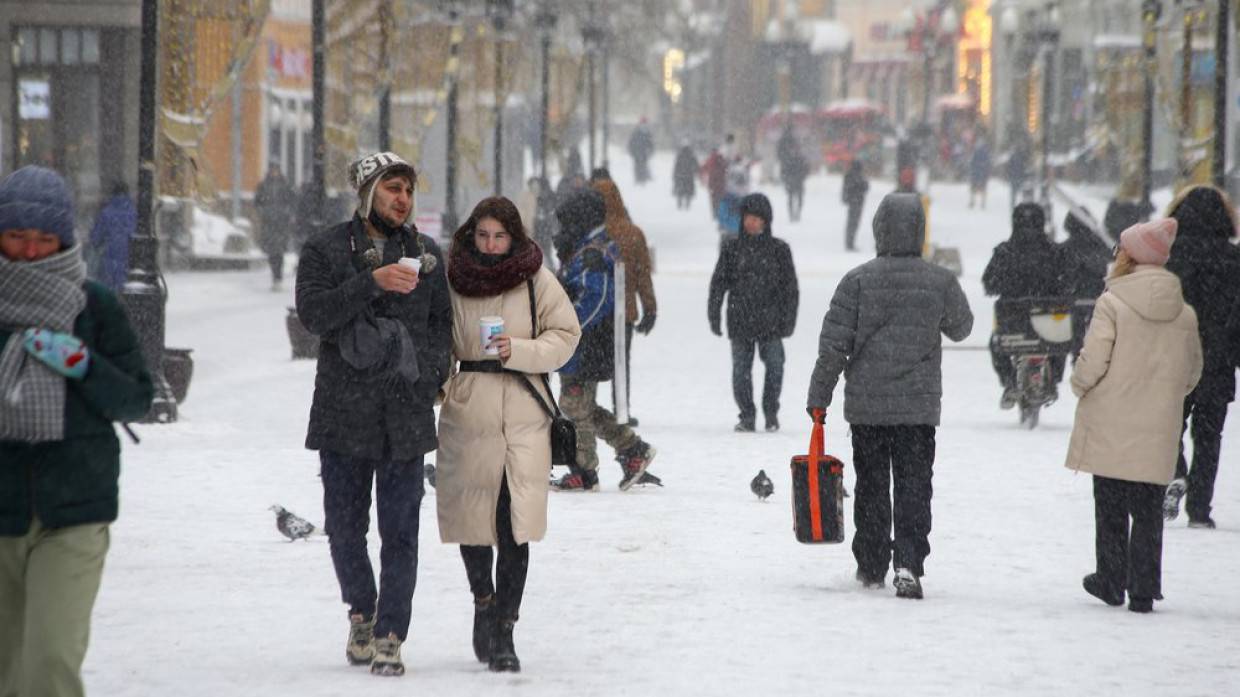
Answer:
[{"xmin": 435, "ymin": 268, "xmax": 582, "ymax": 546}]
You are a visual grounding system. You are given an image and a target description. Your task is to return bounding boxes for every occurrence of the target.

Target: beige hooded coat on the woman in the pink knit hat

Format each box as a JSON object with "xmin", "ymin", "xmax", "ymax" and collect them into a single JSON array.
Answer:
[{"xmin": 1066, "ymin": 264, "xmax": 1202, "ymax": 485}]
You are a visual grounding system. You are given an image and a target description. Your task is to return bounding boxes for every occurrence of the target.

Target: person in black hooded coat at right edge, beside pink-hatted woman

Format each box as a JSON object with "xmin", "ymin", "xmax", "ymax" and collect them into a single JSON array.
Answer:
[{"xmin": 1163, "ymin": 186, "xmax": 1240, "ymax": 528}]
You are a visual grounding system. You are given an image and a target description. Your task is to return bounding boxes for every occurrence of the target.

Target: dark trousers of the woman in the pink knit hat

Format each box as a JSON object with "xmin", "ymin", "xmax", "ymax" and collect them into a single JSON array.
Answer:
[{"xmin": 1094, "ymin": 475, "xmax": 1166, "ymax": 598}]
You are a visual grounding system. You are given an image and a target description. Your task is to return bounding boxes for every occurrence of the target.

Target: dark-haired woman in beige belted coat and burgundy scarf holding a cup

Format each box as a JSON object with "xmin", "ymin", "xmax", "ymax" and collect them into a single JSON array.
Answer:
[{"xmin": 435, "ymin": 197, "xmax": 582, "ymax": 672}]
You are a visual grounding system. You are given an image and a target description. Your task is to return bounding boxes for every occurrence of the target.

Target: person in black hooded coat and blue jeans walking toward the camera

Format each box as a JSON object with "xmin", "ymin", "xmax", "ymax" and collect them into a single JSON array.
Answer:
[{"xmin": 707, "ymin": 193, "xmax": 800, "ymax": 432}]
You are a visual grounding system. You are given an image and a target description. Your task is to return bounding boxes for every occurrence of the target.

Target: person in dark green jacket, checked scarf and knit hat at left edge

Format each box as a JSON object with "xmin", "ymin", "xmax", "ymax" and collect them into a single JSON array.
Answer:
[{"xmin": 0, "ymin": 166, "xmax": 155, "ymax": 697}]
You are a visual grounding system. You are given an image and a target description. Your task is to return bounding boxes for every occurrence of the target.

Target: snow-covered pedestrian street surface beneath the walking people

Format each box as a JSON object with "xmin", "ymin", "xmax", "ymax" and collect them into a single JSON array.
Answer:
[{"xmin": 84, "ymin": 151, "xmax": 1240, "ymax": 697}]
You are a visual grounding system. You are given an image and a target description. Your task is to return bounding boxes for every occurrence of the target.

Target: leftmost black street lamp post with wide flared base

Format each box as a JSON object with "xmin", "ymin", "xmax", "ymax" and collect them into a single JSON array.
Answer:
[{"xmin": 120, "ymin": 0, "xmax": 176, "ymax": 423}]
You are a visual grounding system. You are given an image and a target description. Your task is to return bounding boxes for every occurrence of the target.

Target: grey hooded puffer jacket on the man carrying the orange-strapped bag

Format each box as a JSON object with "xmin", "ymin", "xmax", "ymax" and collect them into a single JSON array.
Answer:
[{"xmin": 808, "ymin": 193, "xmax": 973, "ymax": 425}]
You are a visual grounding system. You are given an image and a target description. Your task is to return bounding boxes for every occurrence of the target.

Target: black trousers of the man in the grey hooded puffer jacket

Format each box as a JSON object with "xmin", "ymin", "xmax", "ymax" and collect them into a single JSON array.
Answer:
[{"xmin": 851, "ymin": 424, "xmax": 935, "ymax": 578}]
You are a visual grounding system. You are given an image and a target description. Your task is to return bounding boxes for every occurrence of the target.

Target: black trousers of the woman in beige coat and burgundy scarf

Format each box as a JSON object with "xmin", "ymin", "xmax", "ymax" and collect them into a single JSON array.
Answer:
[{"xmin": 461, "ymin": 475, "xmax": 529, "ymax": 621}]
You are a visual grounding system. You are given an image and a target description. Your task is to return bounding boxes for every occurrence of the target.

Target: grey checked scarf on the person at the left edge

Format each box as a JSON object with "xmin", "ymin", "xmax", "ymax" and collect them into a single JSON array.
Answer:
[{"xmin": 0, "ymin": 244, "xmax": 86, "ymax": 443}]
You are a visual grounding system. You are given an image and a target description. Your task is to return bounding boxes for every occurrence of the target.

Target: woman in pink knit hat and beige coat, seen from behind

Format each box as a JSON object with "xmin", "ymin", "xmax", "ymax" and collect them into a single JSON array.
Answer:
[{"xmin": 1068, "ymin": 218, "xmax": 1202, "ymax": 613}]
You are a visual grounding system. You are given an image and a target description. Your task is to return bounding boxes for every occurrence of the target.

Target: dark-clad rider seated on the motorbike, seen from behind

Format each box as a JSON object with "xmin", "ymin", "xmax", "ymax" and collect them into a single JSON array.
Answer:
[{"xmin": 982, "ymin": 202, "xmax": 1064, "ymax": 409}]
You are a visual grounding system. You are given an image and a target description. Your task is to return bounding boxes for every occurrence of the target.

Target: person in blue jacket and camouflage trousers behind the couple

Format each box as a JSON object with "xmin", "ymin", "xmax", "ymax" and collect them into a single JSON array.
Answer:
[{"xmin": 552, "ymin": 190, "xmax": 657, "ymax": 491}]
